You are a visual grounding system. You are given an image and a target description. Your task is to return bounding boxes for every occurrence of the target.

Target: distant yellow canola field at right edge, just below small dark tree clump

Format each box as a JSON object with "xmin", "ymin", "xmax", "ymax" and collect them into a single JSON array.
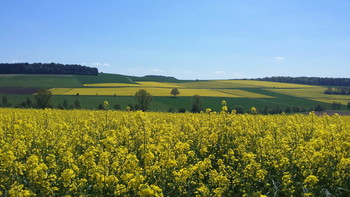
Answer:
[{"xmin": 268, "ymin": 87, "xmax": 350, "ymax": 105}]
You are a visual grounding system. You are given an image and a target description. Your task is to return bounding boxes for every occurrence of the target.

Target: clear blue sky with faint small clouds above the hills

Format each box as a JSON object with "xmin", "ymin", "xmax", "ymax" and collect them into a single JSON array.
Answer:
[{"xmin": 0, "ymin": 0, "xmax": 350, "ymax": 79}]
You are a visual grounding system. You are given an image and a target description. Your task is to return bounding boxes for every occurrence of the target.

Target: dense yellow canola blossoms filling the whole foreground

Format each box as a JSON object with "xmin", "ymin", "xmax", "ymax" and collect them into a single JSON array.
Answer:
[{"xmin": 0, "ymin": 108, "xmax": 350, "ymax": 196}]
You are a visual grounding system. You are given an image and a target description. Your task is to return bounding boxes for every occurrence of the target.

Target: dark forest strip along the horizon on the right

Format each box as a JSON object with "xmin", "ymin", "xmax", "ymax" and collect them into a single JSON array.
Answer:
[{"xmin": 254, "ymin": 77, "xmax": 350, "ymax": 86}]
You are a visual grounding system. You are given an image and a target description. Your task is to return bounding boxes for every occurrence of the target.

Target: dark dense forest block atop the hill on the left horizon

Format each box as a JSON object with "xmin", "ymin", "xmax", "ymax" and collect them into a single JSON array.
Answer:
[{"xmin": 0, "ymin": 63, "xmax": 98, "ymax": 75}]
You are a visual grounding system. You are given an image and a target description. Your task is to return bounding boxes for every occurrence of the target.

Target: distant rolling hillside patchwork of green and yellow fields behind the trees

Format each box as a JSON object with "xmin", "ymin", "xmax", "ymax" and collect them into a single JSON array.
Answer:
[{"xmin": 0, "ymin": 74, "xmax": 350, "ymax": 111}]
